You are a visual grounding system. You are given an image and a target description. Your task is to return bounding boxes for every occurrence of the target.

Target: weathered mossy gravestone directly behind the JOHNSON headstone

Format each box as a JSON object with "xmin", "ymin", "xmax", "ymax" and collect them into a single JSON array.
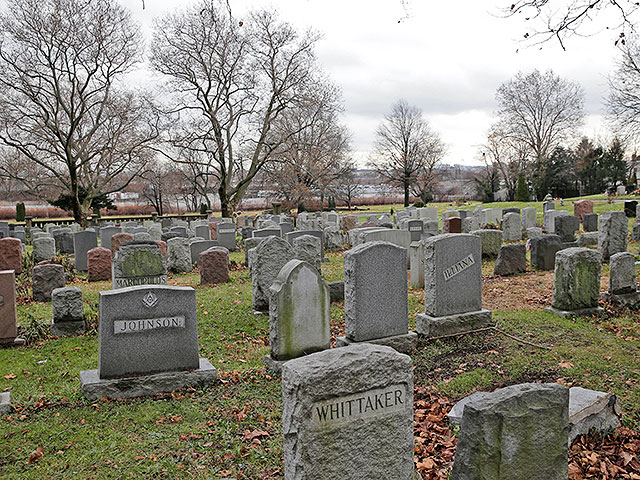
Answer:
[{"xmin": 111, "ymin": 242, "xmax": 167, "ymax": 289}]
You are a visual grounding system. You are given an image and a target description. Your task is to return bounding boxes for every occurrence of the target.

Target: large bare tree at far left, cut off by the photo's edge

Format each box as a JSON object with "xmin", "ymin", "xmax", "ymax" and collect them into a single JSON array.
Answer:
[{"xmin": 0, "ymin": 0, "xmax": 157, "ymax": 225}]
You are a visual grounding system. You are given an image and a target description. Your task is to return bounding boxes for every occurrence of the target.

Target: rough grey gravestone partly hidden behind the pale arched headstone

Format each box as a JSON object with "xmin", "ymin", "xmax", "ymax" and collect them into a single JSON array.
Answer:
[{"xmin": 249, "ymin": 237, "xmax": 295, "ymax": 313}]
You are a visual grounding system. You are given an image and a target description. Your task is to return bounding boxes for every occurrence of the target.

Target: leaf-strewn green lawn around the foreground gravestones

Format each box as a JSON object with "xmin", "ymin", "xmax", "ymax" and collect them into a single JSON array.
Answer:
[{"xmin": 0, "ymin": 249, "xmax": 640, "ymax": 479}]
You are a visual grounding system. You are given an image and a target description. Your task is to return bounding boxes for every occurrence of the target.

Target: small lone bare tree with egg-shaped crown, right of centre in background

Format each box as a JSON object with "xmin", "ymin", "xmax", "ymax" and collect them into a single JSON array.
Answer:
[{"xmin": 370, "ymin": 100, "xmax": 445, "ymax": 207}]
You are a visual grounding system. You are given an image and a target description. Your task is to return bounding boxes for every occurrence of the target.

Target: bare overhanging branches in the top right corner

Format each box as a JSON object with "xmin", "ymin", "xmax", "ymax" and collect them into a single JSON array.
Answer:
[{"xmin": 503, "ymin": 0, "xmax": 640, "ymax": 50}]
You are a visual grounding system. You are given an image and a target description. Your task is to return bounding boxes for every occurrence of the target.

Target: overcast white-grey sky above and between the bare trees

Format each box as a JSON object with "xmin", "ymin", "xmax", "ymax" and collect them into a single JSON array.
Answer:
[{"xmin": 121, "ymin": 0, "xmax": 618, "ymax": 165}]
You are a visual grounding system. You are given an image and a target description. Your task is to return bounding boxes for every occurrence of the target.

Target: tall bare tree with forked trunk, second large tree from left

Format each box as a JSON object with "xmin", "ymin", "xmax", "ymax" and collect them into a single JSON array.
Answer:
[{"xmin": 151, "ymin": 0, "xmax": 318, "ymax": 216}]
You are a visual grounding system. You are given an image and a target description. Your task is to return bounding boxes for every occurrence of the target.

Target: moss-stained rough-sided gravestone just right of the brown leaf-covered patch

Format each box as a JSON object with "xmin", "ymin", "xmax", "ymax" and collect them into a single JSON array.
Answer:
[{"xmin": 547, "ymin": 247, "xmax": 602, "ymax": 317}]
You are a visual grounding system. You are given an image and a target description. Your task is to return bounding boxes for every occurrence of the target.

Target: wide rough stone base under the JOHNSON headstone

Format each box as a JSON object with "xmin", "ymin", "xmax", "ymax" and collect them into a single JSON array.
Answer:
[{"xmin": 80, "ymin": 358, "xmax": 218, "ymax": 401}]
